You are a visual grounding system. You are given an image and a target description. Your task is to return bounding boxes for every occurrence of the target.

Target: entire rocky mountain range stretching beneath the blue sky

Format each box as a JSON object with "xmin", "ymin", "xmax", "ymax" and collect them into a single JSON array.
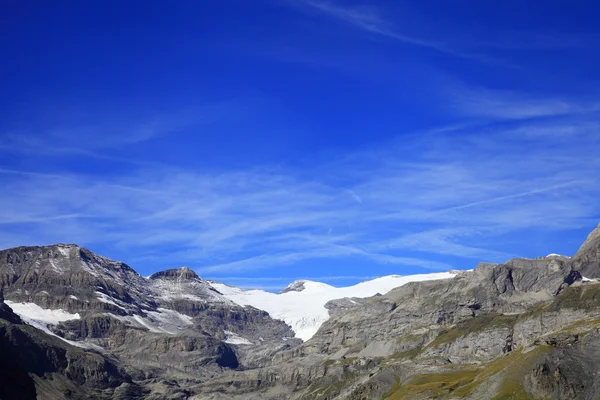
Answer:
[{"xmin": 0, "ymin": 228, "xmax": 600, "ymax": 400}]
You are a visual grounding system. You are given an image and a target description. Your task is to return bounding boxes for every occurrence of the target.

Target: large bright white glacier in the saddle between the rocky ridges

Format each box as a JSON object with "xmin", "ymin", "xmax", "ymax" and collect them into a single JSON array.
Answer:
[{"xmin": 210, "ymin": 272, "xmax": 456, "ymax": 341}]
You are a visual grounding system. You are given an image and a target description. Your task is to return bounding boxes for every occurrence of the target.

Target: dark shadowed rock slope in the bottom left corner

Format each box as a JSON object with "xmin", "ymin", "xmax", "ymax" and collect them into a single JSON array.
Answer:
[{"xmin": 0, "ymin": 304, "xmax": 144, "ymax": 399}]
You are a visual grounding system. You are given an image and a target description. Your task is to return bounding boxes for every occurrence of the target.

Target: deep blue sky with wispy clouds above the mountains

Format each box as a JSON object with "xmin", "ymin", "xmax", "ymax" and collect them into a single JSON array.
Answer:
[{"xmin": 0, "ymin": 0, "xmax": 600, "ymax": 290}]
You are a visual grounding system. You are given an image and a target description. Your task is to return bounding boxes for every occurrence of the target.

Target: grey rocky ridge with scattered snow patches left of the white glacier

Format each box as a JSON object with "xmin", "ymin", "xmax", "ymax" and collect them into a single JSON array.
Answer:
[{"xmin": 0, "ymin": 245, "xmax": 298, "ymax": 398}]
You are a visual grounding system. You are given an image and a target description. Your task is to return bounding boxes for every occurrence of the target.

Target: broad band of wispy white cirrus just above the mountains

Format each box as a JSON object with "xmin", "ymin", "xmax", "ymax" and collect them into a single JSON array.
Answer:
[{"xmin": 0, "ymin": 107, "xmax": 600, "ymax": 277}]
